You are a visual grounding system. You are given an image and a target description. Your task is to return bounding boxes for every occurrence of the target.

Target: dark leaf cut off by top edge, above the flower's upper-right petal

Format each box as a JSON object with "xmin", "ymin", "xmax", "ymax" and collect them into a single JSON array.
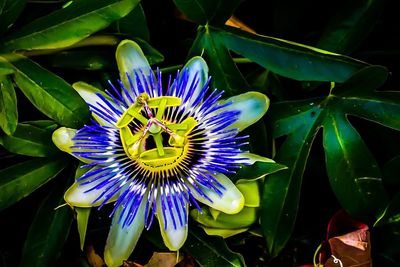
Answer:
[{"xmin": 174, "ymin": 0, "xmax": 240, "ymax": 25}]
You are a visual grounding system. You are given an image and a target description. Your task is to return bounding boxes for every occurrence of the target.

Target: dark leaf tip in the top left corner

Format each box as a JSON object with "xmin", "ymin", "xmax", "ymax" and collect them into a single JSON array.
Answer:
[{"xmin": 0, "ymin": 0, "xmax": 26, "ymax": 35}]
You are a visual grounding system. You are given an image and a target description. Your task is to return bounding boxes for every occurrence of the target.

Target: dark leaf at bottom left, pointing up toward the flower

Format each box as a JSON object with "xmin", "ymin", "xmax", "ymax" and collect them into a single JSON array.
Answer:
[{"xmin": 19, "ymin": 176, "xmax": 73, "ymax": 267}]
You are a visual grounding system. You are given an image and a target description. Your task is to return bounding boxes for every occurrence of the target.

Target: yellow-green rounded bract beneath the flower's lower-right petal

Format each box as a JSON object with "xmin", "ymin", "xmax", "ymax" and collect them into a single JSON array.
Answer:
[{"xmin": 190, "ymin": 207, "xmax": 258, "ymax": 229}]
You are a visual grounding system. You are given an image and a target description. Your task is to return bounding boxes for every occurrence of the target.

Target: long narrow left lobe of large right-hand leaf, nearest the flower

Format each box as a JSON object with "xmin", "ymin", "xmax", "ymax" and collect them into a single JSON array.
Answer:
[{"xmin": 261, "ymin": 103, "xmax": 321, "ymax": 257}]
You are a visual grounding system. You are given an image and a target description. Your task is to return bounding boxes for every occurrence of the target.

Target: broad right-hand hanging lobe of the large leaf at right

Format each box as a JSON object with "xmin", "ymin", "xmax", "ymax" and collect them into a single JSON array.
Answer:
[{"xmin": 323, "ymin": 112, "xmax": 388, "ymax": 220}]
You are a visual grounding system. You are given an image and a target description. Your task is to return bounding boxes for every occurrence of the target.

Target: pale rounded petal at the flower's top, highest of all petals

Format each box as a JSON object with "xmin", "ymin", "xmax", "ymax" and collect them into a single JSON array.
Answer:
[{"xmin": 115, "ymin": 40, "xmax": 155, "ymax": 98}]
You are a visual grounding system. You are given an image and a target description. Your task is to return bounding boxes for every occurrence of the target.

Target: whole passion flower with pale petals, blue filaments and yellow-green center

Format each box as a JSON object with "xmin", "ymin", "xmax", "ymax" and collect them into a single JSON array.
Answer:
[{"xmin": 53, "ymin": 40, "xmax": 269, "ymax": 266}]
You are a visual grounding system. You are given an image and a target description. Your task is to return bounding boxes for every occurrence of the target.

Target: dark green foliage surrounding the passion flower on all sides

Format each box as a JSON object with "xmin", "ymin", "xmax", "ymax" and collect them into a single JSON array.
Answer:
[{"xmin": 0, "ymin": 0, "xmax": 400, "ymax": 267}]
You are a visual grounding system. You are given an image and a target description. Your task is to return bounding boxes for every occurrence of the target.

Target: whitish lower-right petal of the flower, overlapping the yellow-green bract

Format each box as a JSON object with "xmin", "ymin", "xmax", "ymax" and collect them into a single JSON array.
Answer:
[{"xmin": 191, "ymin": 173, "xmax": 244, "ymax": 214}]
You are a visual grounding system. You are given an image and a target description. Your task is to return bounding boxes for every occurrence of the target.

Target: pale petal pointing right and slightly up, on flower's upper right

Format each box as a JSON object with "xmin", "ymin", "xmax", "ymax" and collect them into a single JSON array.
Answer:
[{"xmin": 210, "ymin": 91, "xmax": 269, "ymax": 131}]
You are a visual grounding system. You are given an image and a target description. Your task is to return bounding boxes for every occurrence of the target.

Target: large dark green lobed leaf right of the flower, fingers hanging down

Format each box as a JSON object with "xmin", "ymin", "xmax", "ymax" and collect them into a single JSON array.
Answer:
[{"xmin": 261, "ymin": 67, "xmax": 392, "ymax": 256}]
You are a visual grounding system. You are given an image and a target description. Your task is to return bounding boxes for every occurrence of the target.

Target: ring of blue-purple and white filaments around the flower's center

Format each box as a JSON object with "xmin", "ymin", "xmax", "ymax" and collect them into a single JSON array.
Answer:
[{"xmin": 71, "ymin": 69, "xmax": 247, "ymax": 229}]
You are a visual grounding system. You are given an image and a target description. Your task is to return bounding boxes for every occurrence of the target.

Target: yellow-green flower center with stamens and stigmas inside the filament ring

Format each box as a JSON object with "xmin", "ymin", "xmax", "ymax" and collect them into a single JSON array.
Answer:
[{"xmin": 117, "ymin": 93, "xmax": 197, "ymax": 171}]
